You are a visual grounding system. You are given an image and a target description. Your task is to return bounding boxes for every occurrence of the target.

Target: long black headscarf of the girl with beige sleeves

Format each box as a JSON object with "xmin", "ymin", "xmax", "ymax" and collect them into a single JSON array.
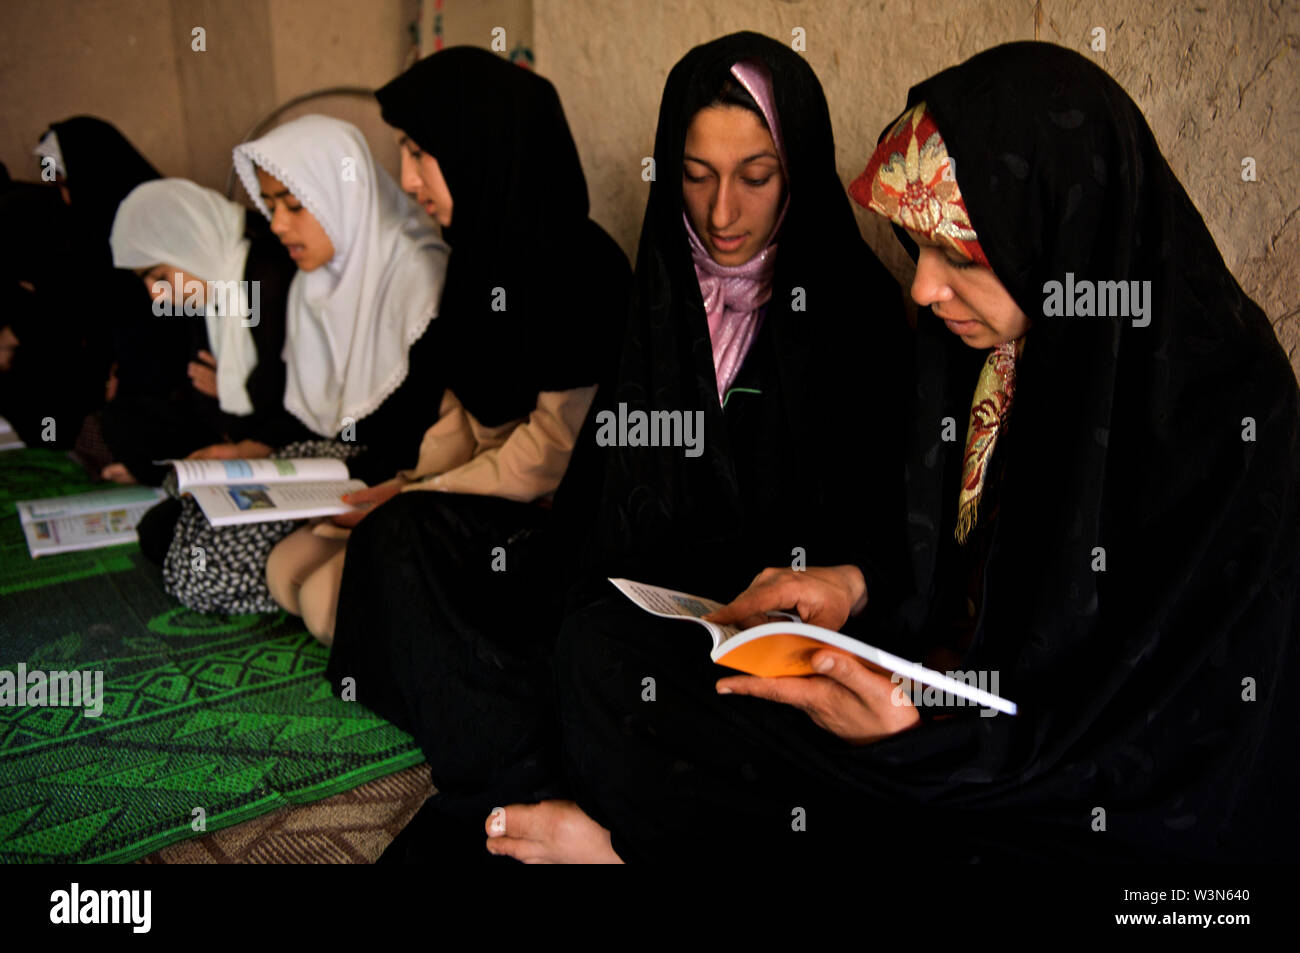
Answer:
[{"xmin": 376, "ymin": 47, "xmax": 629, "ymax": 426}]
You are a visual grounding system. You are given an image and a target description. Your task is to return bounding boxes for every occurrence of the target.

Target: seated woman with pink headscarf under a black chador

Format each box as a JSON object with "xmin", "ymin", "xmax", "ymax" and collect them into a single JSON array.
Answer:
[{"xmin": 351, "ymin": 33, "xmax": 906, "ymax": 861}]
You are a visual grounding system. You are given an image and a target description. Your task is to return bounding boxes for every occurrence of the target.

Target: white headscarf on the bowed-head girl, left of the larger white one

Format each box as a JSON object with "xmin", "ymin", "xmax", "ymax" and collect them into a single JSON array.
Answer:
[{"xmin": 108, "ymin": 178, "xmax": 257, "ymax": 416}]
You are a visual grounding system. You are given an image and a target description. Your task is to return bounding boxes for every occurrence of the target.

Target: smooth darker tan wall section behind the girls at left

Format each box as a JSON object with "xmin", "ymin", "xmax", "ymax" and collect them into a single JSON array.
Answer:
[{"xmin": 0, "ymin": 0, "xmax": 501, "ymax": 196}]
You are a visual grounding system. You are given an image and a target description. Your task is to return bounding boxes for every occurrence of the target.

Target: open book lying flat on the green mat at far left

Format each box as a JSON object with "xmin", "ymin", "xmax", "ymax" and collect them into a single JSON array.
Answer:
[{"xmin": 14, "ymin": 486, "xmax": 166, "ymax": 559}]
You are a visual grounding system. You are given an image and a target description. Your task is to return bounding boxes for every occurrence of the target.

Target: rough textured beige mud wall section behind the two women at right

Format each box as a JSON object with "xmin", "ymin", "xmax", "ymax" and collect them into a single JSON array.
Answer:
[{"xmin": 533, "ymin": 0, "xmax": 1300, "ymax": 373}]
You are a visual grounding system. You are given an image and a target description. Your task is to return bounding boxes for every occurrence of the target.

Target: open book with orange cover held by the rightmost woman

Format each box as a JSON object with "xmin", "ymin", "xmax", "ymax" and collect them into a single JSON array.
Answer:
[{"xmin": 610, "ymin": 579, "xmax": 1017, "ymax": 715}]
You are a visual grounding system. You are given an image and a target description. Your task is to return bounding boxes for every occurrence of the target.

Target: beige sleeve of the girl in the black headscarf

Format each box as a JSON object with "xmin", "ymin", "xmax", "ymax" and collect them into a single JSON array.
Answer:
[{"xmin": 403, "ymin": 385, "xmax": 595, "ymax": 503}]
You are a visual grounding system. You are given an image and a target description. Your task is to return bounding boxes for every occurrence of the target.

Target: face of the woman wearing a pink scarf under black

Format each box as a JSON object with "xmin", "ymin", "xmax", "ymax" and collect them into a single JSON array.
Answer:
[{"xmin": 681, "ymin": 105, "xmax": 785, "ymax": 265}]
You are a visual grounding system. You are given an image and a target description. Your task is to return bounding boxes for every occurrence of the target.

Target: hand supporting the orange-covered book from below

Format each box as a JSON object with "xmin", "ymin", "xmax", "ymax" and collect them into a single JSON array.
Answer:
[{"xmin": 716, "ymin": 649, "xmax": 920, "ymax": 745}]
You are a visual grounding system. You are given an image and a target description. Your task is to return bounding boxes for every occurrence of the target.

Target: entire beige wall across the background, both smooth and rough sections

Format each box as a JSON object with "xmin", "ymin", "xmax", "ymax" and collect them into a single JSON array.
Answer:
[{"xmin": 0, "ymin": 0, "xmax": 1300, "ymax": 369}]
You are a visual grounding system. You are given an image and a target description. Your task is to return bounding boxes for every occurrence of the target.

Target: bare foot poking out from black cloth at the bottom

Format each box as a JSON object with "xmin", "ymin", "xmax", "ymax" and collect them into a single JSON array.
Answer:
[{"xmin": 484, "ymin": 801, "xmax": 623, "ymax": 863}]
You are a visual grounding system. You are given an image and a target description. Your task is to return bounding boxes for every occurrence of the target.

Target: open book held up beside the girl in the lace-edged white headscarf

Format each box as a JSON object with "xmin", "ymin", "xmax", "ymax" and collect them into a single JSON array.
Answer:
[{"xmin": 160, "ymin": 458, "xmax": 365, "ymax": 527}]
